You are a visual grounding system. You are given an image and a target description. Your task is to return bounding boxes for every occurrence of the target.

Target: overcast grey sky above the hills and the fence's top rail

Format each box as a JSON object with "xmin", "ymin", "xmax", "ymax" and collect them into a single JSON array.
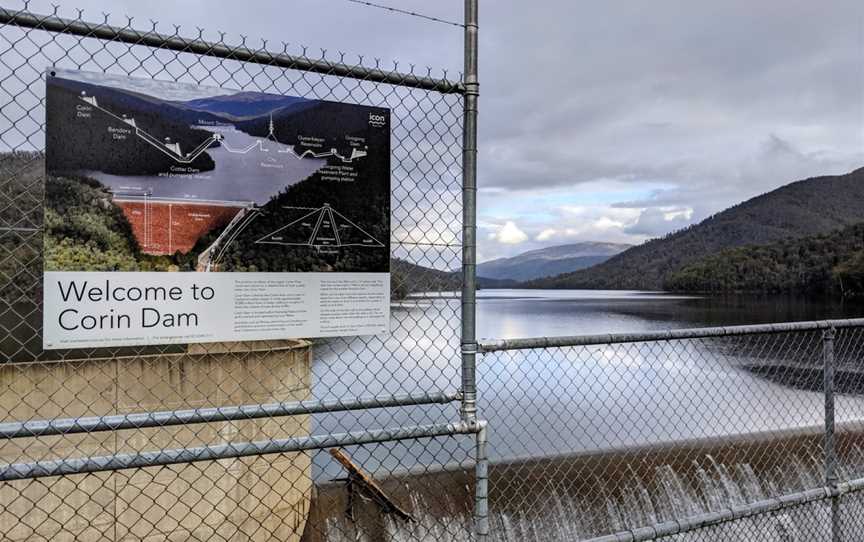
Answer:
[{"xmin": 31, "ymin": 0, "xmax": 864, "ymax": 260}]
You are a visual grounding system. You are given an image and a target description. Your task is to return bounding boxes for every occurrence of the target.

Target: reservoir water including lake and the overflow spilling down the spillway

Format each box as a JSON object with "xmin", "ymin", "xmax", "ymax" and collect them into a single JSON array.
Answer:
[{"xmin": 313, "ymin": 290, "xmax": 864, "ymax": 542}]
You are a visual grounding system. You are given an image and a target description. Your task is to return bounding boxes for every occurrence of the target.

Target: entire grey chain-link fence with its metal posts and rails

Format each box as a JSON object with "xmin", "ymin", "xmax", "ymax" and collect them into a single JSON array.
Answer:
[{"xmin": 0, "ymin": 0, "xmax": 864, "ymax": 542}]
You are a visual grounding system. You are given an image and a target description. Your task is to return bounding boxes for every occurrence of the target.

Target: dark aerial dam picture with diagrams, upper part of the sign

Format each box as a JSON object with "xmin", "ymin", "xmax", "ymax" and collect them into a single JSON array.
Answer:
[{"xmin": 45, "ymin": 68, "xmax": 390, "ymax": 272}]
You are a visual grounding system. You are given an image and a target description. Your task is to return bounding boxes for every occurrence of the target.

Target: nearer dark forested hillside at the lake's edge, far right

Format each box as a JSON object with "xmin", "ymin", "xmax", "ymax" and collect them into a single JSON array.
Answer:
[{"xmin": 666, "ymin": 223, "xmax": 864, "ymax": 297}]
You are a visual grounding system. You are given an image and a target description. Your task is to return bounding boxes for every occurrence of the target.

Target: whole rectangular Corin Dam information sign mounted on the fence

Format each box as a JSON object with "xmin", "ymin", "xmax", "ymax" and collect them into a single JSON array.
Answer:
[{"xmin": 43, "ymin": 69, "xmax": 390, "ymax": 349}]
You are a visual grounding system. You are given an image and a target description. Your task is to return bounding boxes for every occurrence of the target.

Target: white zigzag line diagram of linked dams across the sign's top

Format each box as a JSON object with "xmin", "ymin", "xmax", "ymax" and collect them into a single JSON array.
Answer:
[{"xmin": 81, "ymin": 91, "xmax": 368, "ymax": 164}]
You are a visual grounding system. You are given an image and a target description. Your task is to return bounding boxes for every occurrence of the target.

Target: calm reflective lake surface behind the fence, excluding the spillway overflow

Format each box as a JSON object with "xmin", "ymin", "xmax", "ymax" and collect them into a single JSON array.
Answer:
[{"xmin": 313, "ymin": 290, "xmax": 864, "ymax": 478}]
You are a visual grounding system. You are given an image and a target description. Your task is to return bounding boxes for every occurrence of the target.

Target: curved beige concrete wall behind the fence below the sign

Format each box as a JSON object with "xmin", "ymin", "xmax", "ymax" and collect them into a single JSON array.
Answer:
[{"xmin": 0, "ymin": 341, "xmax": 312, "ymax": 541}]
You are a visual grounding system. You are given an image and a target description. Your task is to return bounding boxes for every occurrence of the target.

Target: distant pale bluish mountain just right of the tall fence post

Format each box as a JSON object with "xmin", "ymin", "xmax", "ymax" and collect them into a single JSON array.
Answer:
[{"xmin": 477, "ymin": 242, "xmax": 632, "ymax": 281}]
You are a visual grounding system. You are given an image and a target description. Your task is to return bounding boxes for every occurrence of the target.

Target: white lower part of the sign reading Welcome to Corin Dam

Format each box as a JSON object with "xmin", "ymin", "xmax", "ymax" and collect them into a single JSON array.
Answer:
[{"xmin": 44, "ymin": 271, "xmax": 390, "ymax": 349}]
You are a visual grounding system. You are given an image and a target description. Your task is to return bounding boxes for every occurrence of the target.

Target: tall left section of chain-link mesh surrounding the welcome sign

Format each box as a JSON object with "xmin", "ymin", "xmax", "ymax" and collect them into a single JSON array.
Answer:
[{"xmin": 0, "ymin": 2, "xmax": 474, "ymax": 541}]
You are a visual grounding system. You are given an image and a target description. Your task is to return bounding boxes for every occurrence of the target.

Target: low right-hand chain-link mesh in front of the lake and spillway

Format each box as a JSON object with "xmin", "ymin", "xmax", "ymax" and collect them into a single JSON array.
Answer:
[{"xmin": 478, "ymin": 328, "xmax": 864, "ymax": 541}]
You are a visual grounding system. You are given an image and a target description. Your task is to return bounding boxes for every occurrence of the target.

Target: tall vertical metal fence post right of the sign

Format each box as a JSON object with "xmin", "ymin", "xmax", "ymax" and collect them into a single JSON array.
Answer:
[{"xmin": 461, "ymin": 0, "xmax": 480, "ymax": 422}]
